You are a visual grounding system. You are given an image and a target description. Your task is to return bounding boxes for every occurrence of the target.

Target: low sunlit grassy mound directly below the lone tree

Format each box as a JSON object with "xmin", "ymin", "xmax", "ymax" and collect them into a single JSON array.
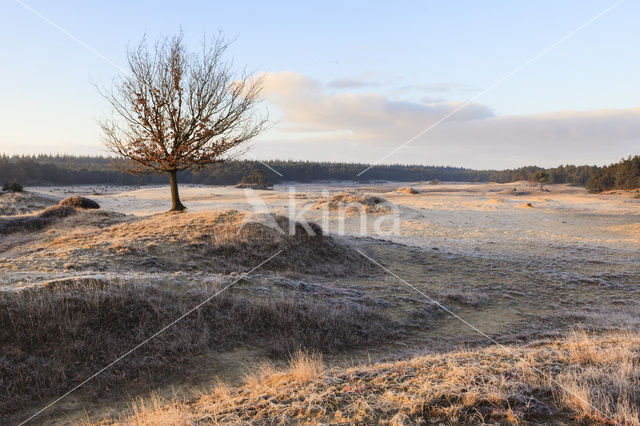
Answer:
[{"xmin": 22, "ymin": 211, "xmax": 371, "ymax": 275}]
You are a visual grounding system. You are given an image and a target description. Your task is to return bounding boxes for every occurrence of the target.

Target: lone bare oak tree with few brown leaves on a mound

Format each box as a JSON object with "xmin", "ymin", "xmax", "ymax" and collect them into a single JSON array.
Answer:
[{"xmin": 100, "ymin": 33, "xmax": 267, "ymax": 211}]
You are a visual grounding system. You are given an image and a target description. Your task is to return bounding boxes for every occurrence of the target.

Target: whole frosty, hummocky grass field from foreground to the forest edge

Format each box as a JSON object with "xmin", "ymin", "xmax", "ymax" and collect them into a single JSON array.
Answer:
[{"xmin": 0, "ymin": 182, "xmax": 640, "ymax": 424}]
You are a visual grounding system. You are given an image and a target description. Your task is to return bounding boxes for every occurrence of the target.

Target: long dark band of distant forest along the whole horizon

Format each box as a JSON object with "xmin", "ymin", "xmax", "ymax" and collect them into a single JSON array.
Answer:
[{"xmin": 0, "ymin": 155, "xmax": 640, "ymax": 192}]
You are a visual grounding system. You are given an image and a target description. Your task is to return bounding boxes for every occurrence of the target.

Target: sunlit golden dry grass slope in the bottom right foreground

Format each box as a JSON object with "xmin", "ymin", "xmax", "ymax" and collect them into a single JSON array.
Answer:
[{"xmin": 102, "ymin": 332, "xmax": 640, "ymax": 425}]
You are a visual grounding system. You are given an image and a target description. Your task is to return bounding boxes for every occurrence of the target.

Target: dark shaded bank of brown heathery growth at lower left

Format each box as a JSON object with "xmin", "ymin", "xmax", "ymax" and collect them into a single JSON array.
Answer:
[{"xmin": 0, "ymin": 281, "xmax": 394, "ymax": 415}]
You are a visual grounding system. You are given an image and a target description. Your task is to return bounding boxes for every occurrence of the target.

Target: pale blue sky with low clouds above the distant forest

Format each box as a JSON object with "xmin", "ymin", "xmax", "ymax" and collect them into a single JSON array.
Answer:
[{"xmin": 0, "ymin": 0, "xmax": 640, "ymax": 168}]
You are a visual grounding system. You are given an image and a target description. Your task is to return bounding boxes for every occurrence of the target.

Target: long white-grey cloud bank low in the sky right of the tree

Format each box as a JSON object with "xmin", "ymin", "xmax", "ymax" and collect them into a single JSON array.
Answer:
[{"xmin": 254, "ymin": 71, "xmax": 640, "ymax": 168}]
